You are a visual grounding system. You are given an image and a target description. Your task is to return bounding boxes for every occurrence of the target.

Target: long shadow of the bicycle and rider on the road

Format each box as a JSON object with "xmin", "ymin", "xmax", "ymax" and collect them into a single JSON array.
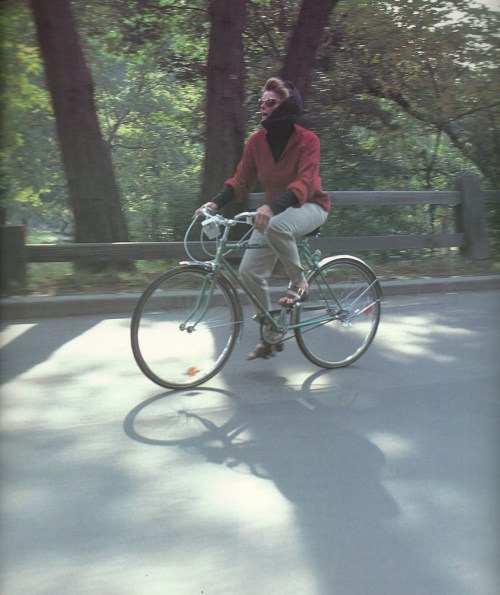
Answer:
[{"xmin": 124, "ymin": 371, "xmax": 449, "ymax": 594}]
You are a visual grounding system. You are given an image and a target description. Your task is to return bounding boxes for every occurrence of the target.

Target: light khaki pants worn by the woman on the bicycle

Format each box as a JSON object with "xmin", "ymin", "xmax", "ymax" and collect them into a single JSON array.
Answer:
[{"xmin": 239, "ymin": 203, "xmax": 328, "ymax": 310}]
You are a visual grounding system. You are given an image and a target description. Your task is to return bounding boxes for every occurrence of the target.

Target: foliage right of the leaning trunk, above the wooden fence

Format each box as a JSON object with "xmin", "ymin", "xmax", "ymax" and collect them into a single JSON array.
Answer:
[{"xmin": 310, "ymin": 0, "xmax": 500, "ymax": 189}]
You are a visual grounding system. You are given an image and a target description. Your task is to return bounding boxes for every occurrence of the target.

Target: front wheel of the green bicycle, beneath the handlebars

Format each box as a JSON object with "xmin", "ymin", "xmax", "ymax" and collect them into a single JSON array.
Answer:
[{"xmin": 131, "ymin": 266, "xmax": 242, "ymax": 388}]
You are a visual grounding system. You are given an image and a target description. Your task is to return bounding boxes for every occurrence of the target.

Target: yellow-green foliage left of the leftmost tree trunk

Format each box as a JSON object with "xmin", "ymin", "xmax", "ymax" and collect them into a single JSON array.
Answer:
[{"xmin": 0, "ymin": 2, "xmax": 66, "ymax": 226}]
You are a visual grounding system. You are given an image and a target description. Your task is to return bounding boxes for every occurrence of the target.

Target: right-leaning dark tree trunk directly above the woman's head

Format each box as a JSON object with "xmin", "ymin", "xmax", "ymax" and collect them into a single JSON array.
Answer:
[{"xmin": 280, "ymin": 0, "xmax": 340, "ymax": 96}]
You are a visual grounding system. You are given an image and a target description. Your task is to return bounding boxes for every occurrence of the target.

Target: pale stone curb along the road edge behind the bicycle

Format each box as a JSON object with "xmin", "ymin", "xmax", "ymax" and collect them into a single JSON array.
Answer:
[{"xmin": 0, "ymin": 275, "xmax": 500, "ymax": 321}]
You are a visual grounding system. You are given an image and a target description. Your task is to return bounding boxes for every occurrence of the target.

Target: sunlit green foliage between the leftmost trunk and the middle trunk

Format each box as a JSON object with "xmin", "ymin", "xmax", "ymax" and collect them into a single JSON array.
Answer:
[{"xmin": 77, "ymin": 1, "xmax": 208, "ymax": 240}]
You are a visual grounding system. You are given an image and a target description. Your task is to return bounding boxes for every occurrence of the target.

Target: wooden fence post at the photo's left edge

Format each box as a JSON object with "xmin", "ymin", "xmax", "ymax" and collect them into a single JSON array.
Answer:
[{"xmin": 0, "ymin": 225, "xmax": 26, "ymax": 289}]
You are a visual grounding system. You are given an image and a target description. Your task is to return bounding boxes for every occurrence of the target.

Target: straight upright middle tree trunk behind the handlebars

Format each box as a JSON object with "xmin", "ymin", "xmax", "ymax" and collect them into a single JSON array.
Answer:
[{"xmin": 201, "ymin": 0, "xmax": 246, "ymax": 202}]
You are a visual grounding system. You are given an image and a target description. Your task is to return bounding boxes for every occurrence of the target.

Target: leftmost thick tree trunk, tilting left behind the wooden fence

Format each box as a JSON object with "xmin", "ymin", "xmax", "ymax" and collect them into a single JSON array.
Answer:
[{"xmin": 30, "ymin": 0, "xmax": 128, "ymax": 247}]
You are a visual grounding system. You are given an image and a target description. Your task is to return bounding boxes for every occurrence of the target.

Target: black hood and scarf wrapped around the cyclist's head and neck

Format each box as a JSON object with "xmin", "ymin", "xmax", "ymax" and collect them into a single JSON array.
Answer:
[{"xmin": 262, "ymin": 81, "xmax": 302, "ymax": 161}]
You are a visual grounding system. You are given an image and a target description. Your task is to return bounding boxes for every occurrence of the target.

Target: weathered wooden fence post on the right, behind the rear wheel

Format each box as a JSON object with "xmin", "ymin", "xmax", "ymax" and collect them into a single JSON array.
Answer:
[{"xmin": 457, "ymin": 174, "xmax": 490, "ymax": 261}]
